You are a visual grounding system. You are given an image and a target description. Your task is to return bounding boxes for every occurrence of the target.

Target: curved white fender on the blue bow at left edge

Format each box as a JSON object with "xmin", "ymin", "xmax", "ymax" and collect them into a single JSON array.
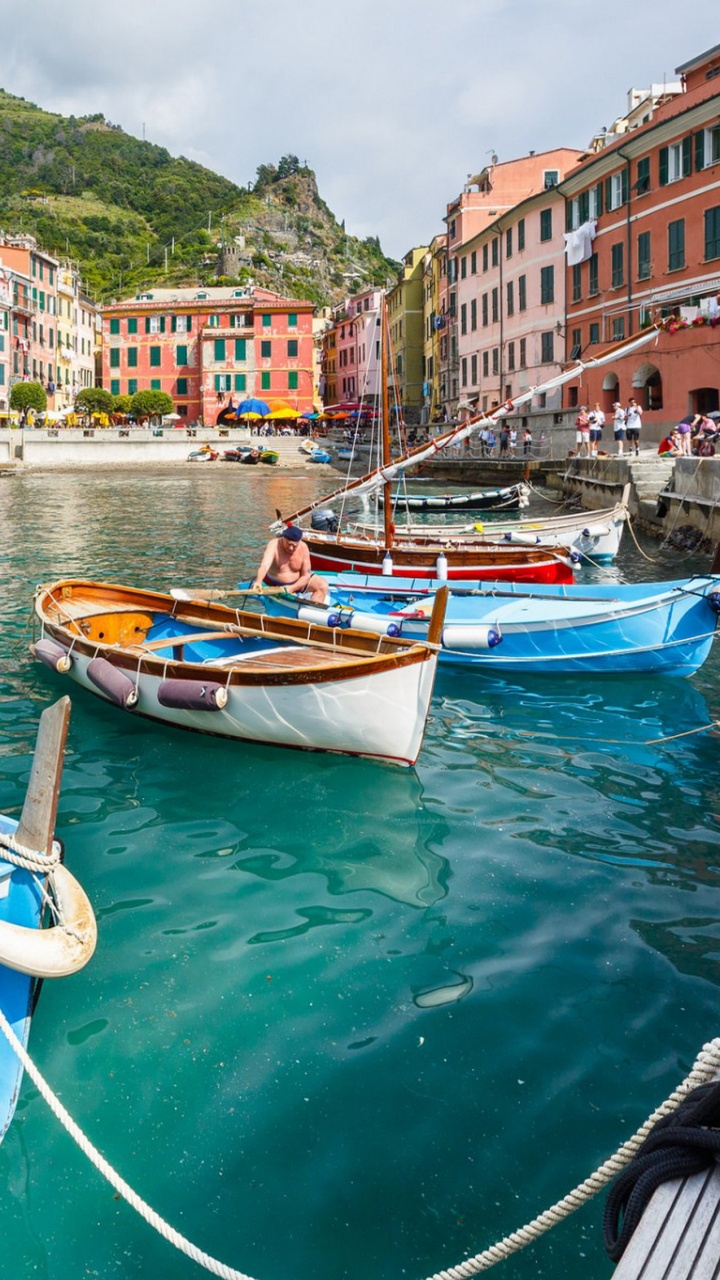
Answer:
[{"xmin": 0, "ymin": 865, "xmax": 97, "ymax": 978}]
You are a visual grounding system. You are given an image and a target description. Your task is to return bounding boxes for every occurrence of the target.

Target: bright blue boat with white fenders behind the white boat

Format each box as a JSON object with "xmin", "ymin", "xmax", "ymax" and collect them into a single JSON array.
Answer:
[{"xmin": 253, "ymin": 572, "xmax": 720, "ymax": 676}]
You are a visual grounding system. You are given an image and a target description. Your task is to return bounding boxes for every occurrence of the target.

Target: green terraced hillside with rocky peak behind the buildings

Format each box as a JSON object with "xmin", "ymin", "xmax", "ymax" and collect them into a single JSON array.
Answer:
[{"xmin": 0, "ymin": 90, "xmax": 398, "ymax": 306}]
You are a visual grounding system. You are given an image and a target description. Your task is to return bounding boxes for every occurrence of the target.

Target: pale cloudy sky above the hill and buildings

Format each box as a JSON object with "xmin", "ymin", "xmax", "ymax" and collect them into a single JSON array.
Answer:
[{"xmin": 0, "ymin": 0, "xmax": 720, "ymax": 257}]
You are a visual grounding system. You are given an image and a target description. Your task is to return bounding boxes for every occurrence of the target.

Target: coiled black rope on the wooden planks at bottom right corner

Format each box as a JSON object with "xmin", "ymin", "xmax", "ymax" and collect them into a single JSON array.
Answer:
[{"xmin": 602, "ymin": 1083, "xmax": 720, "ymax": 1262}]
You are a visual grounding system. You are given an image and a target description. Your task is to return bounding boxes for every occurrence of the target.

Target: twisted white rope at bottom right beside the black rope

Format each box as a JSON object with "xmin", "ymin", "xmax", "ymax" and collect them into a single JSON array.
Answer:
[{"xmin": 429, "ymin": 1038, "xmax": 720, "ymax": 1280}]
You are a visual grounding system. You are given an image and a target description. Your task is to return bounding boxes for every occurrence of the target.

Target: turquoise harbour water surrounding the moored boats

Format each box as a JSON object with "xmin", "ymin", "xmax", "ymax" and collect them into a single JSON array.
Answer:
[{"xmin": 0, "ymin": 467, "xmax": 720, "ymax": 1280}]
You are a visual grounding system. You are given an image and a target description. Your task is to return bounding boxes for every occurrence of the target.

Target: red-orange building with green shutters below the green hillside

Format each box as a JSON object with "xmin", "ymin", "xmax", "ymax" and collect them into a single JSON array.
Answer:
[{"xmin": 102, "ymin": 288, "xmax": 315, "ymax": 424}]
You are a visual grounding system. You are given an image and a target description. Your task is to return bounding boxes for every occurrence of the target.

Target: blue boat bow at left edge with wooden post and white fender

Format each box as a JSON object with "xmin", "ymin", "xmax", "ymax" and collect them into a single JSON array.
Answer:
[{"xmin": 0, "ymin": 698, "xmax": 97, "ymax": 1142}]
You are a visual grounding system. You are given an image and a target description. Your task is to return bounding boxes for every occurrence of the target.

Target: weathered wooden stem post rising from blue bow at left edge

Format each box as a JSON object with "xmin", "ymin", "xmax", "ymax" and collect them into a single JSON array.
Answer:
[{"xmin": 17, "ymin": 698, "xmax": 70, "ymax": 855}]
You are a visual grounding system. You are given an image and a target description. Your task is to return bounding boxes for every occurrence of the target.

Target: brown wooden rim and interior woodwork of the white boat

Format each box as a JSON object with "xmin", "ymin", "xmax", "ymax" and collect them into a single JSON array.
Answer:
[{"xmin": 35, "ymin": 580, "xmax": 433, "ymax": 686}]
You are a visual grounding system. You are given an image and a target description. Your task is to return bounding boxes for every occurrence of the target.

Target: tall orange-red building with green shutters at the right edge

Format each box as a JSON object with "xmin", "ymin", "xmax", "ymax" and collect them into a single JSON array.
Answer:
[{"xmin": 560, "ymin": 46, "xmax": 720, "ymax": 424}]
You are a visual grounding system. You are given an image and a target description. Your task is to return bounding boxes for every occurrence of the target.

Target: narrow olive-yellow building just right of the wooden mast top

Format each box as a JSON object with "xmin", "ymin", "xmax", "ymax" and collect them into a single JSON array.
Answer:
[{"xmin": 387, "ymin": 244, "xmax": 428, "ymax": 422}]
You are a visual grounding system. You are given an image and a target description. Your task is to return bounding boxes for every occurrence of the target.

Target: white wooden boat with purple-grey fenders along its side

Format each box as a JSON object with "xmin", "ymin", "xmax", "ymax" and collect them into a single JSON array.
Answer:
[{"xmin": 32, "ymin": 579, "xmax": 447, "ymax": 765}]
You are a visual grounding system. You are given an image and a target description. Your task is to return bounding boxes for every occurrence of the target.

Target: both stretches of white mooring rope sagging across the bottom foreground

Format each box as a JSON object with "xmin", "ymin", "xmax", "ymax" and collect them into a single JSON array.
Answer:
[{"xmin": 0, "ymin": 1009, "xmax": 720, "ymax": 1280}]
